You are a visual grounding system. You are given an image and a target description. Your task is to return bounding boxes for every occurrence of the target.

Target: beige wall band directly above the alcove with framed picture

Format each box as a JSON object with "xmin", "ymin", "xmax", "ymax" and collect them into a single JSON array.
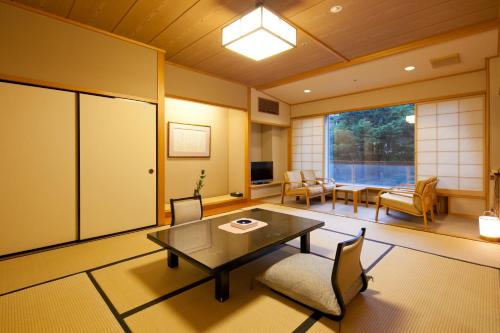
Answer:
[{"xmin": 165, "ymin": 63, "xmax": 248, "ymax": 110}]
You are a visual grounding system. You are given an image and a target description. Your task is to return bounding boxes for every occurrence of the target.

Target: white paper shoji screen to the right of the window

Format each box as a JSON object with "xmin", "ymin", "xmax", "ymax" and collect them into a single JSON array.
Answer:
[{"xmin": 416, "ymin": 96, "xmax": 485, "ymax": 192}]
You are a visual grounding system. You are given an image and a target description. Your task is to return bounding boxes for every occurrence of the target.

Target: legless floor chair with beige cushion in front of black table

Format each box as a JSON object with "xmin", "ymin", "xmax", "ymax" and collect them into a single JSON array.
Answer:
[{"xmin": 256, "ymin": 228, "xmax": 368, "ymax": 320}]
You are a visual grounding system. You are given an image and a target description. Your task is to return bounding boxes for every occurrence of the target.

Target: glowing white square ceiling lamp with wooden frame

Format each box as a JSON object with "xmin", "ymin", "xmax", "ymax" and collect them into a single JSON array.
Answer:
[{"xmin": 222, "ymin": 6, "xmax": 297, "ymax": 61}]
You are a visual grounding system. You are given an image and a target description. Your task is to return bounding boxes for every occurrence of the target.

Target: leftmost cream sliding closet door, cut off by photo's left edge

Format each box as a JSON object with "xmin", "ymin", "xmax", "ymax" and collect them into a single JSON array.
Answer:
[{"xmin": 0, "ymin": 82, "xmax": 77, "ymax": 255}]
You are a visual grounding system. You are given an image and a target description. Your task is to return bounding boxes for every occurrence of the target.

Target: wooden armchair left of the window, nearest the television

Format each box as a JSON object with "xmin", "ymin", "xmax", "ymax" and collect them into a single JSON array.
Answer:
[{"xmin": 281, "ymin": 171, "xmax": 325, "ymax": 208}]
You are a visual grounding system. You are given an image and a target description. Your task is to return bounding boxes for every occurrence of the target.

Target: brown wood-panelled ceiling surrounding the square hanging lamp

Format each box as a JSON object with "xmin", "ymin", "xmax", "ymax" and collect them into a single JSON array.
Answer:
[{"xmin": 13, "ymin": 0, "xmax": 499, "ymax": 86}]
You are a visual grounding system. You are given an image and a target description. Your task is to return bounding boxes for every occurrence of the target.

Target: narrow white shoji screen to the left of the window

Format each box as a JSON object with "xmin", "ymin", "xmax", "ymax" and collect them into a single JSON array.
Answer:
[{"xmin": 292, "ymin": 117, "xmax": 325, "ymax": 177}]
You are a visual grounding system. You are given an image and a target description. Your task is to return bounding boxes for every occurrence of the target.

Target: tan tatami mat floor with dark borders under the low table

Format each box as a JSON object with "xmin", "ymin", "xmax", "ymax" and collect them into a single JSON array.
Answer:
[{"xmin": 0, "ymin": 204, "xmax": 500, "ymax": 332}]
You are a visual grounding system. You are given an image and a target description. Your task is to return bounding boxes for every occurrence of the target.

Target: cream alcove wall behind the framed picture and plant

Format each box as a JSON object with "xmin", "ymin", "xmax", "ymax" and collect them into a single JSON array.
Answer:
[{"xmin": 165, "ymin": 98, "xmax": 247, "ymax": 203}]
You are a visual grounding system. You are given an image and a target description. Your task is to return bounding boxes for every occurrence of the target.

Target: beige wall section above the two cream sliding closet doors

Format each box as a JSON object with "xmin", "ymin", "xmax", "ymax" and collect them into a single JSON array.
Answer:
[{"xmin": 0, "ymin": 3, "xmax": 157, "ymax": 99}]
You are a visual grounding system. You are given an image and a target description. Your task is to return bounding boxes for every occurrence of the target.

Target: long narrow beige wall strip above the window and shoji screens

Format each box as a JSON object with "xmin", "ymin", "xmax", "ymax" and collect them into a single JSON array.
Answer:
[{"xmin": 291, "ymin": 71, "xmax": 486, "ymax": 117}]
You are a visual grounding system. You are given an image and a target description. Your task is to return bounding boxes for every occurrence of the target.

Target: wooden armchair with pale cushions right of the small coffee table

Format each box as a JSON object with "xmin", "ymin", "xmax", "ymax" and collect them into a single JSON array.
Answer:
[{"xmin": 375, "ymin": 177, "xmax": 438, "ymax": 229}]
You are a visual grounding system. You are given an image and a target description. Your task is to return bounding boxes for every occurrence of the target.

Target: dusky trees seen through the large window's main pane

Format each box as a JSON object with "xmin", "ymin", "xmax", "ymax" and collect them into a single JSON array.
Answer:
[{"xmin": 328, "ymin": 104, "xmax": 415, "ymax": 164}]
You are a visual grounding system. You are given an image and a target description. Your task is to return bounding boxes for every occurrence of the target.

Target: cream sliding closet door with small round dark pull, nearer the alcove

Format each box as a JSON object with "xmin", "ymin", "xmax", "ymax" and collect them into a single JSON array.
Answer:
[{"xmin": 80, "ymin": 94, "xmax": 156, "ymax": 239}]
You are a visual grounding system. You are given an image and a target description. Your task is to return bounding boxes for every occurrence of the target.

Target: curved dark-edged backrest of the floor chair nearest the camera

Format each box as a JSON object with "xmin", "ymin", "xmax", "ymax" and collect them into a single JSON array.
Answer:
[{"xmin": 332, "ymin": 228, "xmax": 368, "ymax": 313}]
